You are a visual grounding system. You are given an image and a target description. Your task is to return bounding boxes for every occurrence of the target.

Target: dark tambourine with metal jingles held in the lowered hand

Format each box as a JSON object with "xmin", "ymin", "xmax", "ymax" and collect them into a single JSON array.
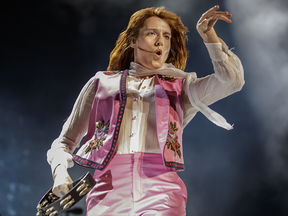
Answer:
[{"xmin": 36, "ymin": 172, "xmax": 96, "ymax": 216}]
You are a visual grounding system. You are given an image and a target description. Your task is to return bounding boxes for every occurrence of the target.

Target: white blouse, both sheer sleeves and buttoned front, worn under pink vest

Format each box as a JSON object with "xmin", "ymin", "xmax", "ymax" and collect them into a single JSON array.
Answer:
[{"xmin": 47, "ymin": 42, "xmax": 244, "ymax": 171}]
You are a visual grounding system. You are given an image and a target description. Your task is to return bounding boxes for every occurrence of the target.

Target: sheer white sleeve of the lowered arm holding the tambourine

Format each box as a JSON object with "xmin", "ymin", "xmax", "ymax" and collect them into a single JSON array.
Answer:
[{"xmin": 47, "ymin": 76, "xmax": 95, "ymax": 173}]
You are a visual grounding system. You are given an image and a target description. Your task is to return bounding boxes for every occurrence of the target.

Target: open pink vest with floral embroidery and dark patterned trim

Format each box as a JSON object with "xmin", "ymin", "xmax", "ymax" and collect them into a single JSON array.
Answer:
[{"xmin": 73, "ymin": 70, "xmax": 184, "ymax": 170}]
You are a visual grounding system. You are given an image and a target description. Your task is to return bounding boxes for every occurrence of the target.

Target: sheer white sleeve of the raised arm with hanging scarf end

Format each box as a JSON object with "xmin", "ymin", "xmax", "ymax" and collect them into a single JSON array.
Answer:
[{"xmin": 183, "ymin": 41, "xmax": 245, "ymax": 130}]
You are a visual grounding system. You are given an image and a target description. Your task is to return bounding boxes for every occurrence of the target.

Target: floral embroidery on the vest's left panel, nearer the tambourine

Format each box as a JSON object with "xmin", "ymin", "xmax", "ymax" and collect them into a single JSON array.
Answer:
[{"xmin": 85, "ymin": 120, "xmax": 110, "ymax": 154}]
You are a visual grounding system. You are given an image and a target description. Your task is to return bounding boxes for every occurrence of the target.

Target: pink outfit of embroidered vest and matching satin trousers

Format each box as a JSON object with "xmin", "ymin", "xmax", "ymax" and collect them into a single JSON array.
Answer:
[{"xmin": 73, "ymin": 70, "xmax": 187, "ymax": 216}]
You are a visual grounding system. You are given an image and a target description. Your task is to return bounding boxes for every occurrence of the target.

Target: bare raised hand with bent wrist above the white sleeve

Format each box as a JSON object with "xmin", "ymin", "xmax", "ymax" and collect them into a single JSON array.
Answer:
[{"xmin": 196, "ymin": 5, "xmax": 232, "ymax": 43}]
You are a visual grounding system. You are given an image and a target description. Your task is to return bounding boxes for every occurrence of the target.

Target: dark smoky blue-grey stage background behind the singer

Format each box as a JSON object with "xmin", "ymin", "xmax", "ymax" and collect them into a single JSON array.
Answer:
[{"xmin": 0, "ymin": 0, "xmax": 288, "ymax": 216}]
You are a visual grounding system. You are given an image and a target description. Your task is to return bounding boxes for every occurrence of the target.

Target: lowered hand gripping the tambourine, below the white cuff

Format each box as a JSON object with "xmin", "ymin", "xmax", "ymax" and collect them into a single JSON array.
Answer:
[{"xmin": 52, "ymin": 164, "xmax": 73, "ymax": 197}]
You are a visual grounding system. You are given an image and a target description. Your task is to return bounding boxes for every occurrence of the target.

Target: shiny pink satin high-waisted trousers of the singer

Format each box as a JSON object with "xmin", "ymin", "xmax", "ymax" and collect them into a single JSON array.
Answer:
[{"xmin": 86, "ymin": 152, "xmax": 187, "ymax": 216}]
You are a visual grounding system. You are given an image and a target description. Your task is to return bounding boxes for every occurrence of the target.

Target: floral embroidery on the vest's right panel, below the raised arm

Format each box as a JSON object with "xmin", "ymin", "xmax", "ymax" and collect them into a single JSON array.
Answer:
[{"xmin": 166, "ymin": 122, "xmax": 181, "ymax": 158}]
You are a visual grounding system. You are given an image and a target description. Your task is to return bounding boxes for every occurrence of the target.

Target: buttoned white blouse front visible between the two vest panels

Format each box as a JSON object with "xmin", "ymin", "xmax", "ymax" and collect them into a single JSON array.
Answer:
[{"xmin": 116, "ymin": 76, "xmax": 161, "ymax": 154}]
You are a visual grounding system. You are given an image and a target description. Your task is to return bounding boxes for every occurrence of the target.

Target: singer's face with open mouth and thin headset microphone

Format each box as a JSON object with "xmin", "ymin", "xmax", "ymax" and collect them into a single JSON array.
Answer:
[{"xmin": 132, "ymin": 16, "xmax": 171, "ymax": 69}]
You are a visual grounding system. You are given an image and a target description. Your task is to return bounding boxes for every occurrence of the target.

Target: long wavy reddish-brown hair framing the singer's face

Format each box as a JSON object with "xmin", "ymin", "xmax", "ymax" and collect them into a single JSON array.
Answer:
[{"xmin": 107, "ymin": 6, "xmax": 188, "ymax": 71}]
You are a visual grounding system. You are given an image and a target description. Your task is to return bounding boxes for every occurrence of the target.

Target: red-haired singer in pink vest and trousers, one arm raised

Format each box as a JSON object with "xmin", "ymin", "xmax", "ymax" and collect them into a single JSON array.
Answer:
[{"xmin": 47, "ymin": 6, "xmax": 244, "ymax": 215}]
